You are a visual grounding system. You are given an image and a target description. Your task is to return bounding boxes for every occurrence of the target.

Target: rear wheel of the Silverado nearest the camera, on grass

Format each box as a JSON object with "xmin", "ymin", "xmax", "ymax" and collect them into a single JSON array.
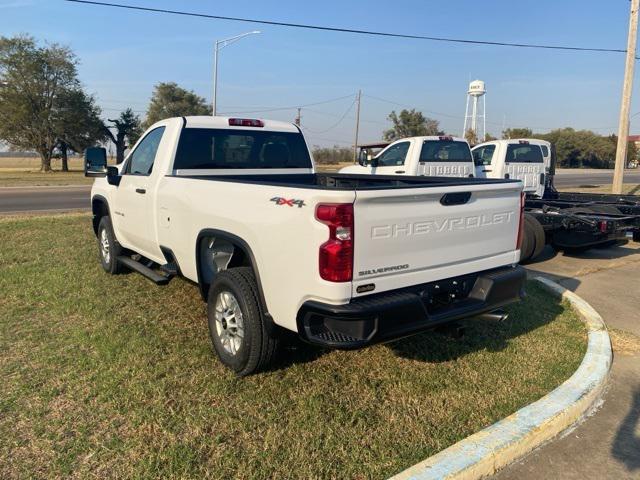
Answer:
[{"xmin": 207, "ymin": 267, "xmax": 280, "ymax": 376}]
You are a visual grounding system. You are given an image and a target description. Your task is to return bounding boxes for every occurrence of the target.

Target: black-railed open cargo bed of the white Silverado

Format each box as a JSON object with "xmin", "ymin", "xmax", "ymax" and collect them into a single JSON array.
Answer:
[{"xmin": 173, "ymin": 173, "xmax": 518, "ymax": 190}]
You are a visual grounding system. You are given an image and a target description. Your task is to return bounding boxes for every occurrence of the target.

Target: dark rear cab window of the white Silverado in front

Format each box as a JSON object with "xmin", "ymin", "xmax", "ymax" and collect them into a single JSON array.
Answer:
[{"xmin": 173, "ymin": 128, "xmax": 312, "ymax": 170}]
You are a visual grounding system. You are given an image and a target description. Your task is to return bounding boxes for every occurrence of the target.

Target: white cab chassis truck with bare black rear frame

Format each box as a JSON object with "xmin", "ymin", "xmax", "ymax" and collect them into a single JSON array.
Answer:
[{"xmin": 472, "ymin": 138, "xmax": 640, "ymax": 262}]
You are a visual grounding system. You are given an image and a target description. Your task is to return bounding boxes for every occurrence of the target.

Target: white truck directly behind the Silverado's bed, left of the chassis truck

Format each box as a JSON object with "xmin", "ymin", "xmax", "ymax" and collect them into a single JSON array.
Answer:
[{"xmin": 340, "ymin": 136, "xmax": 475, "ymax": 177}]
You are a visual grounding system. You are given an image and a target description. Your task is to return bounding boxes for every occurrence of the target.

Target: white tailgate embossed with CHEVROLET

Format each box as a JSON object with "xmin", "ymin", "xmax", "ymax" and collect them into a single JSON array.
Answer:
[{"xmin": 353, "ymin": 183, "xmax": 522, "ymax": 297}]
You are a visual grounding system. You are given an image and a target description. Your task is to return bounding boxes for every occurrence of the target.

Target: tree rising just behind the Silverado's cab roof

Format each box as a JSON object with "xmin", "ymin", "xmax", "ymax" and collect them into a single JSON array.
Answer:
[{"xmin": 144, "ymin": 82, "xmax": 211, "ymax": 128}]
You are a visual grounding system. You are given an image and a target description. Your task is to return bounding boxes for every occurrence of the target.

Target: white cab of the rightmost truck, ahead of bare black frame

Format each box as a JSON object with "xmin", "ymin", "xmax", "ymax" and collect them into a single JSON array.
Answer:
[{"xmin": 471, "ymin": 138, "xmax": 551, "ymax": 198}]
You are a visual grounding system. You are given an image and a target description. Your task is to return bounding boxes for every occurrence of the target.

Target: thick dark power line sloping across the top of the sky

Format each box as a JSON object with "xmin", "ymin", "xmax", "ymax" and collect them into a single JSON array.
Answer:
[{"xmin": 65, "ymin": 0, "xmax": 637, "ymax": 58}]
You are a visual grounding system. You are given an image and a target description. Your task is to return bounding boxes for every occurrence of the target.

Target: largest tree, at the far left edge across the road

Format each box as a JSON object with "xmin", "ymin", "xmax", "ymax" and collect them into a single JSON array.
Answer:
[{"xmin": 0, "ymin": 36, "xmax": 81, "ymax": 172}]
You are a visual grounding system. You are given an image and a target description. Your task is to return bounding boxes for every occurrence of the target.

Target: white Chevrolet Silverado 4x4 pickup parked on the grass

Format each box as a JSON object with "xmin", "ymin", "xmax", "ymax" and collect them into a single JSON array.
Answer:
[{"xmin": 85, "ymin": 117, "xmax": 525, "ymax": 375}]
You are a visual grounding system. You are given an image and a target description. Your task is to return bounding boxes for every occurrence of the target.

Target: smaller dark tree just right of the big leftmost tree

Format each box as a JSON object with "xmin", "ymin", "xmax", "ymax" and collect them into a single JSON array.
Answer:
[{"xmin": 56, "ymin": 90, "xmax": 106, "ymax": 172}]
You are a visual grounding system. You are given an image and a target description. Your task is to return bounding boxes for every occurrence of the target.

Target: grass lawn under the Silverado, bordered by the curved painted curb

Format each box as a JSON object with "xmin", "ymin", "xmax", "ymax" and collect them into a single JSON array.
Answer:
[{"xmin": 0, "ymin": 214, "xmax": 586, "ymax": 479}]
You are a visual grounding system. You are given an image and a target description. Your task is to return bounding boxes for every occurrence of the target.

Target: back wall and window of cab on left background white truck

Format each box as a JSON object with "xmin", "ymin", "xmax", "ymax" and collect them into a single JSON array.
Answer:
[{"xmin": 416, "ymin": 137, "xmax": 475, "ymax": 177}]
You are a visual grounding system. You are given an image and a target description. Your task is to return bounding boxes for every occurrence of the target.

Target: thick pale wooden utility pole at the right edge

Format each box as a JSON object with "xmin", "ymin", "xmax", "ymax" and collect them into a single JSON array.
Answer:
[{"xmin": 612, "ymin": 0, "xmax": 640, "ymax": 194}]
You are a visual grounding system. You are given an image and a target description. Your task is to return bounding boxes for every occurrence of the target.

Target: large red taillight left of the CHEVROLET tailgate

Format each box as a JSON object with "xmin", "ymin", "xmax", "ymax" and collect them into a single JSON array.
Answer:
[{"xmin": 316, "ymin": 203, "xmax": 353, "ymax": 282}]
